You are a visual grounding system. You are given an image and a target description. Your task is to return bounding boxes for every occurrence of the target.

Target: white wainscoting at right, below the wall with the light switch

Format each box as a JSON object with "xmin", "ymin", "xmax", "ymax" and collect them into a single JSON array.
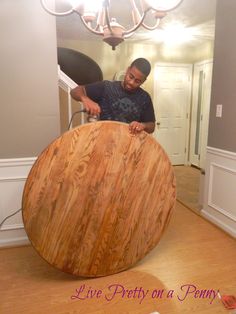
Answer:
[{"xmin": 201, "ymin": 147, "xmax": 236, "ymax": 238}]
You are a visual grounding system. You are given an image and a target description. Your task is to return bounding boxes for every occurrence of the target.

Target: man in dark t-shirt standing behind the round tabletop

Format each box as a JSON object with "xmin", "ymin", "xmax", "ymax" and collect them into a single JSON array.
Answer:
[{"xmin": 71, "ymin": 58, "xmax": 155, "ymax": 134}]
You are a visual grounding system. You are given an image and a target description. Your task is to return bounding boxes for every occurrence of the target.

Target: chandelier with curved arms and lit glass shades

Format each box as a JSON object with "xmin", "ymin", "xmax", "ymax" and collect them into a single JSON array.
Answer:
[{"xmin": 40, "ymin": 0, "xmax": 183, "ymax": 50}]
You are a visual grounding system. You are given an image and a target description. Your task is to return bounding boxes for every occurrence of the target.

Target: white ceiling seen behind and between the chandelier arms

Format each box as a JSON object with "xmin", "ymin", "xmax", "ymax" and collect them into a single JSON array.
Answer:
[{"xmin": 54, "ymin": 0, "xmax": 217, "ymax": 46}]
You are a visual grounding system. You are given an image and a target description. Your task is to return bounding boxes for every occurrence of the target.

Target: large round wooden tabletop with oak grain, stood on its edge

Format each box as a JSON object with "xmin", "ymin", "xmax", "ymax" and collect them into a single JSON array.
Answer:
[{"xmin": 22, "ymin": 121, "xmax": 176, "ymax": 277}]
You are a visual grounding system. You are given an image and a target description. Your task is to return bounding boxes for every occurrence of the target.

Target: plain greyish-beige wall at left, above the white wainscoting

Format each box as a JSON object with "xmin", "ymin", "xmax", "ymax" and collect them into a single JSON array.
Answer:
[{"xmin": 0, "ymin": 0, "xmax": 59, "ymax": 158}]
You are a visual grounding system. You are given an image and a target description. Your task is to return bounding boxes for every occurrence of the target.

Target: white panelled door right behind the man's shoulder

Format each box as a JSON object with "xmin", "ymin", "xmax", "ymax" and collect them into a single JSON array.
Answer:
[{"xmin": 154, "ymin": 63, "xmax": 192, "ymax": 165}]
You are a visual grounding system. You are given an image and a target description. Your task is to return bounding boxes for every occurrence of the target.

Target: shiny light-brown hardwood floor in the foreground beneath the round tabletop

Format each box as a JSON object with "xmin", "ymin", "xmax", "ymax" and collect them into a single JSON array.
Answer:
[{"xmin": 0, "ymin": 202, "xmax": 236, "ymax": 314}]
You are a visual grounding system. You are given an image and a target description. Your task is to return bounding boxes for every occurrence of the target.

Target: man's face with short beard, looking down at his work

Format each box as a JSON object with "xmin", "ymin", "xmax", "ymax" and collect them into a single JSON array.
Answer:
[{"xmin": 123, "ymin": 66, "xmax": 146, "ymax": 92}]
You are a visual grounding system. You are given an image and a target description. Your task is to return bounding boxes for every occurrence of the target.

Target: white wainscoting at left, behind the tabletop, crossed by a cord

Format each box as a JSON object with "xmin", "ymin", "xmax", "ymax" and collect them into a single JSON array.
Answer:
[{"xmin": 0, "ymin": 157, "xmax": 36, "ymax": 247}]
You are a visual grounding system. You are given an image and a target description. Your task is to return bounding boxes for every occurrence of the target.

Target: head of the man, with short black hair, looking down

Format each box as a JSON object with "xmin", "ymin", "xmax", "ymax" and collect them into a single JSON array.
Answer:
[{"xmin": 123, "ymin": 58, "xmax": 151, "ymax": 92}]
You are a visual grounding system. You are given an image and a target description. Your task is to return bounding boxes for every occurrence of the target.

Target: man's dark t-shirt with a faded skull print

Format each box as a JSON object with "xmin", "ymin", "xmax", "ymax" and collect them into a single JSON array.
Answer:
[{"xmin": 85, "ymin": 81, "xmax": 155, "ymax": 123}]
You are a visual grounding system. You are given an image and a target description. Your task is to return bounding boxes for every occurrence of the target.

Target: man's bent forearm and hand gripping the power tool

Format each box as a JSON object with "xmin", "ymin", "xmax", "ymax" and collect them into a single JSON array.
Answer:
[{"xmin": 70, "ymin": 85, "xmax": 101, "ymax": 115}]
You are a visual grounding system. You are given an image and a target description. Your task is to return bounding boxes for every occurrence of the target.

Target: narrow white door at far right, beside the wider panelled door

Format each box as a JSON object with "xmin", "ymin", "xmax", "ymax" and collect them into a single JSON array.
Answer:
[{"xmin": 190, "ymin": 60, "xmax": 213, "ymax": 168}]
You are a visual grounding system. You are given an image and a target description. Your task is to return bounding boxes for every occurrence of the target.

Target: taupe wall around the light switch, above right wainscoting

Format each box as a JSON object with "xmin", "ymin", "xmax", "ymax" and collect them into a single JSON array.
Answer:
[{"xmin": 208, "ymin": 0, "xmax": 236, "ymax": 153}]
